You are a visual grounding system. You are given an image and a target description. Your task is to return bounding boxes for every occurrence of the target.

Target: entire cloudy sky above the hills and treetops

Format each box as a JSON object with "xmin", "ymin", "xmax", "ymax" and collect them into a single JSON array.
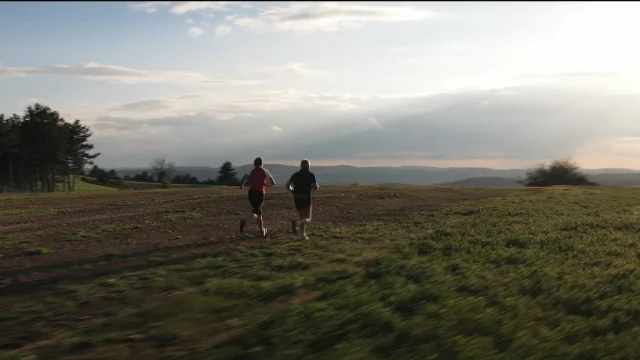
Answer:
[{"xmin": 0, "ymin": 1, "xmax": 640, "ymax": 169}]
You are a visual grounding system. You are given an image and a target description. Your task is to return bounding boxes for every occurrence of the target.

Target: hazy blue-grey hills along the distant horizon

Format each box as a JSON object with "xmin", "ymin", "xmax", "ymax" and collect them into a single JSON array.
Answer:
[{"xmin": 115, "ymin": 164, "xmax": 640, "ymax": 187}]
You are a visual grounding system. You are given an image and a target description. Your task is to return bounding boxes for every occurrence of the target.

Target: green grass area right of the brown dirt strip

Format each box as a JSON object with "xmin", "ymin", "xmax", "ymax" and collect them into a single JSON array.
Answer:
[{"xmin": 6, "ymin": 189, "xmax": 640, "ymax": 360}]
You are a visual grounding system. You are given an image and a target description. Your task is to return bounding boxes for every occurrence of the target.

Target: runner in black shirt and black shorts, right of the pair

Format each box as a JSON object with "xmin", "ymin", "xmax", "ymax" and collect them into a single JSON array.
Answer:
[{"xmin": 286, "ymin": 159, "xmax": 319, "ymax": 240}]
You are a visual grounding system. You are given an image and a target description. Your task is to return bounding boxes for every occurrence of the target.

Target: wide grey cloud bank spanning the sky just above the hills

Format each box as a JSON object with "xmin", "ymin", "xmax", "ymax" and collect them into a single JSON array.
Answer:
[{"xmin": 66, "ymin": 77, "xmax": 640, "ymax": 167}]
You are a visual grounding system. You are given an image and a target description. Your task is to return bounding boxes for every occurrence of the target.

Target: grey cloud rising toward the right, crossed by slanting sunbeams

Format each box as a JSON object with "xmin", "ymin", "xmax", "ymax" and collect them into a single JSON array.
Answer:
[{"xmin": 273, "ymin": 88, "xmax": 640, "ymax": 160}]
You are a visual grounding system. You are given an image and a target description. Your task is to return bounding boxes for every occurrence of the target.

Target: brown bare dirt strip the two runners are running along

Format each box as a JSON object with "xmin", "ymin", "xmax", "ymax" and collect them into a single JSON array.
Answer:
[{"xmin": 0, "ymin": 188, "xmax": 505, "ymax": 349}]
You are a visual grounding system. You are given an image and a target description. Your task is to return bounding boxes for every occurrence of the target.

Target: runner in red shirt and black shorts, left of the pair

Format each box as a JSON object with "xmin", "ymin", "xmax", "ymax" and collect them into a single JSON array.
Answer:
[{"xmin": 240, "ymin": 157, "xmax": 276, "ymax": 237}]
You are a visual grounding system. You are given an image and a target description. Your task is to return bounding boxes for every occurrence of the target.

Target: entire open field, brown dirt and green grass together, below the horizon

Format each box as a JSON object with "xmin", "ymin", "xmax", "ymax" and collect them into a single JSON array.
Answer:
[{"xmin": 0, "ymin": 187, "xmax": 640, "ymax": 360}]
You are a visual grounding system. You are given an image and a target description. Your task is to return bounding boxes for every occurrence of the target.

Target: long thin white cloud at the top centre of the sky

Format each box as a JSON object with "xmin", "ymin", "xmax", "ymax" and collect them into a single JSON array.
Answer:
[{"xmin": 227, "ymin": 2, "xmax": 435, "ymax": 33}]
